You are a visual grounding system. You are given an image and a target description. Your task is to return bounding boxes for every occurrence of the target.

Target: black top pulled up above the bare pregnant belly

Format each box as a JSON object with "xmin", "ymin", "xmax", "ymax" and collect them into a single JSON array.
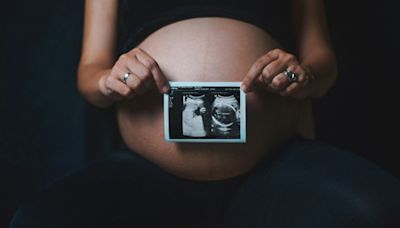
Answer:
[{"xmin": 119, "ymin": 0, "xmax": 294, "ymax": 53}]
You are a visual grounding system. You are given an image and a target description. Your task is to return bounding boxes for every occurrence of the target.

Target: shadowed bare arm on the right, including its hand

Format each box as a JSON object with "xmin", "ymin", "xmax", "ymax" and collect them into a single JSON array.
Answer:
[{"xmin": 242, "ymin": 0, "xmax": 337, "ymax": 98}]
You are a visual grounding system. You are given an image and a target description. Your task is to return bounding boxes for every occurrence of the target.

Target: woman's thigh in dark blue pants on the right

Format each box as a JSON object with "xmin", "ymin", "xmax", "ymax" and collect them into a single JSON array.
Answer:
[{"xmin": 225, "ymin": 140, "xmax": 400, "ymax": 228}]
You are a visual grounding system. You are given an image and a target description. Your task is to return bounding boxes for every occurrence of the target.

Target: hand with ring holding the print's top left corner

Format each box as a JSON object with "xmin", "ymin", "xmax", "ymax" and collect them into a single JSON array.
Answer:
[{"xmin": 99, "ymin": 48, "xmax": 169, "ymax": 101}]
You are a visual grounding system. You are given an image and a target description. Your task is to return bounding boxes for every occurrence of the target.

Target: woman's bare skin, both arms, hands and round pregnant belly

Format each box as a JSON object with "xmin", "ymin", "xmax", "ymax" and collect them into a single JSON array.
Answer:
[{"xmin": 78, "ymin": 0, "xmax": 336, "ymax": 180}]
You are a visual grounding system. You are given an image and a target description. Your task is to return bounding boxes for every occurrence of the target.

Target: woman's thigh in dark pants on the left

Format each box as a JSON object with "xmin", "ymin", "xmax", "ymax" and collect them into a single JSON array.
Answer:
[{"xmin": 11, "ymin": 151, "xmax": 225, "ymax": 228}]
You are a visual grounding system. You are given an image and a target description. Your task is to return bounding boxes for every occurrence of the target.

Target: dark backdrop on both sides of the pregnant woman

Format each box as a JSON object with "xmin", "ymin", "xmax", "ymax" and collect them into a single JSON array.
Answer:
[{"xmin": 0, "ymin": 0, "xmax": 400, "ymax": 227}]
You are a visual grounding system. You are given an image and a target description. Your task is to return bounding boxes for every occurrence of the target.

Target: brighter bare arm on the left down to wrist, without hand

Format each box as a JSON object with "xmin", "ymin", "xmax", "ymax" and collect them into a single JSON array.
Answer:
[{"xmin": 78, "ymin": 0, "xmax": 118, "ymax": 107}]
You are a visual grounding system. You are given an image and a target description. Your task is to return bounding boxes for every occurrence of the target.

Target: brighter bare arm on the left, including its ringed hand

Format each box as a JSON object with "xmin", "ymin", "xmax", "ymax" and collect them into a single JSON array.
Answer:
[{"xmin": 77, "ymin": 0, "xmax": 168, "ymax": 107}]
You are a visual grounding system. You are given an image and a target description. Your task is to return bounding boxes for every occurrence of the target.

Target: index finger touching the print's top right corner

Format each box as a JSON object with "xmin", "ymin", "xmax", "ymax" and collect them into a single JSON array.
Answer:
[{"xmin": 241, "ymin": 51, "xmax": 279, "ymax": 92}]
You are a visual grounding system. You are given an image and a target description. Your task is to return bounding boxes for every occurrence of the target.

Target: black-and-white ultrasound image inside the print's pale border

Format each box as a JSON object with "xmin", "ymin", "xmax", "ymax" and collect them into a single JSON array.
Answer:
[{"xmin": 168, "ymin": 87, "xmax": 240, "ymax": 139}]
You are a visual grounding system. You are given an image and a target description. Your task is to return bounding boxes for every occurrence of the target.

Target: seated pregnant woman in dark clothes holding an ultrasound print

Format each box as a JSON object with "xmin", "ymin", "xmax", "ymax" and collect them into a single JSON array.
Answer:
[{"xmin": 11, "ymin": 0, "xmax": 400, "ymax": 228}]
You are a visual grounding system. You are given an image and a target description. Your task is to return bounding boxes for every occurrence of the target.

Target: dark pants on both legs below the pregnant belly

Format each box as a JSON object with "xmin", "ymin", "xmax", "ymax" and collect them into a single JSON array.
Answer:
[{"xmin": 10, "ymin": 140, "xmax": 400, "ymax": 228}]
